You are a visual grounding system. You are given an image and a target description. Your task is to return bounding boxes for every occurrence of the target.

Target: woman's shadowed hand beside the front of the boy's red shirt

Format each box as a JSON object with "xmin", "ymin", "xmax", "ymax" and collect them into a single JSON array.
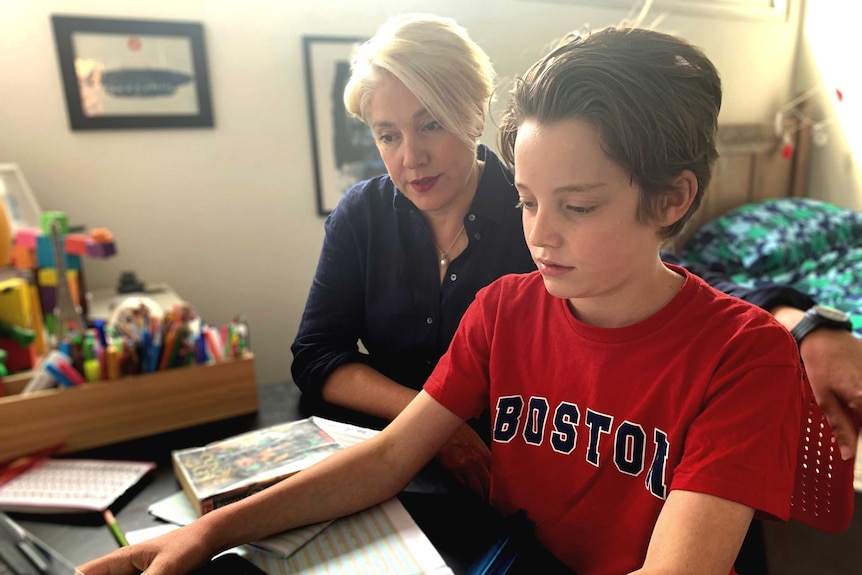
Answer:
[{"xmin": 438, "ymin": 423, "xmax": 491, "ymax": 500}]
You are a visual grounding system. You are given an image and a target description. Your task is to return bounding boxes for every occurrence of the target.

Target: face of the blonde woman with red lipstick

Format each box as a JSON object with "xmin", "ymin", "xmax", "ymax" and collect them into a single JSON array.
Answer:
[{"xmin": 367, "ymin": 73, "xmax": 478, "ymax": 216}]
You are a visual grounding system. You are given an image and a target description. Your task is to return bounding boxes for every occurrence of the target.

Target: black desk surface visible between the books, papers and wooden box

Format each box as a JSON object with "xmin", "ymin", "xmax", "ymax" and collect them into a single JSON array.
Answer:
[{"xmin": 10, "ymin": 383, "xmax": 506, "ymax": 573}]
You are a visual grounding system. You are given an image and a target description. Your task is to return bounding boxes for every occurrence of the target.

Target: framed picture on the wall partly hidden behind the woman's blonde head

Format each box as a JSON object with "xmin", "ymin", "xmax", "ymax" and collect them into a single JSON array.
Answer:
[{"xmin": 302, "ymin": 36, "xmax": 386, "ymax": 216}]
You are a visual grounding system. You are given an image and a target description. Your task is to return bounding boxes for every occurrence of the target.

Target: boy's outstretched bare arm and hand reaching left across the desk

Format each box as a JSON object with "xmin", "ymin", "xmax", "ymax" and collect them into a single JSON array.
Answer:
[{"xmin": 79, "ymin": 392, "xmax": 463, "ymax": 575}]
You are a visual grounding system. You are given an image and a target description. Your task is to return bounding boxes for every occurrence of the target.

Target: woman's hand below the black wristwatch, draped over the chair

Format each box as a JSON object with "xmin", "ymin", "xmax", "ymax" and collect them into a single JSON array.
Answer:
[{"xmin": 799, "ymin": 329, "xmax": 862, "ymax": 460}]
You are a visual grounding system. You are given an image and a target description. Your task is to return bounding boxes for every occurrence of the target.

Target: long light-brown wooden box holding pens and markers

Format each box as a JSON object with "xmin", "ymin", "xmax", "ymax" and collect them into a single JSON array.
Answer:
[{"xmin": 0, "ymin": 356, "xmax": 258, "ymax": 462}]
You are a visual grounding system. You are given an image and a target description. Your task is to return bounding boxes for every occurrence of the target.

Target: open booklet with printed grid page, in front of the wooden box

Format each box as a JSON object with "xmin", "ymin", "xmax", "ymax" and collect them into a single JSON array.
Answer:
[{"xmin": 0, "ymin": 457, "xmax": 155, "ymax": 513}]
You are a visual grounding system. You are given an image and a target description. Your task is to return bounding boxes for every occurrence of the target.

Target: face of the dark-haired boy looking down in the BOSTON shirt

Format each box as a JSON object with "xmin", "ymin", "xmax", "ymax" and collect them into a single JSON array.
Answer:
[{"xmin": 514, "ymin": 119, "xmax": 661, "ymax": 308}]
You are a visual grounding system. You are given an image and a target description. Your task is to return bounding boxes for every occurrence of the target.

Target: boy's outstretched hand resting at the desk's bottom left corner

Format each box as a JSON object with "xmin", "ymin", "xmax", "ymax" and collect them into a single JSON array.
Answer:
[{"xmin": 75, "ymin": 522, "xmax": 213, "ymax": 575}]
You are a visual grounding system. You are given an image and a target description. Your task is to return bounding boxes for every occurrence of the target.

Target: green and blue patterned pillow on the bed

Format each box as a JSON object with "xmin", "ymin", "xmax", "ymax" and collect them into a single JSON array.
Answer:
[{"xmin": 681, "ymin": 198, "xmax": 862, "ymax": 275}]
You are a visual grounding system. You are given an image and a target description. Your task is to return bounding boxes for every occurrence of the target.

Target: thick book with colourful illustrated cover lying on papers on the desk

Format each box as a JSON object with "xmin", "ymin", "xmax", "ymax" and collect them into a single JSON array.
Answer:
[{"xmin": 171, "ymin": 418, "xmax": 341, "ymax": 515}]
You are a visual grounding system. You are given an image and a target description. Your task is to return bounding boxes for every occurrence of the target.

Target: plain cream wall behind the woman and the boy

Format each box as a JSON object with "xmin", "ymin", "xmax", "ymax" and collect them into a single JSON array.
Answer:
[{"xmin": 0, "ymin": 0, "xmax": 798, "ymax": 388}]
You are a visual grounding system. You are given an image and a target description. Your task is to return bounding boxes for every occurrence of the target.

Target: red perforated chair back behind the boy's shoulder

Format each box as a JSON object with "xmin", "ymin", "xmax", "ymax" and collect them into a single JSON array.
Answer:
[{"xmin": 790, "ymin": 372, "xmax": 854, "ymax": 533}]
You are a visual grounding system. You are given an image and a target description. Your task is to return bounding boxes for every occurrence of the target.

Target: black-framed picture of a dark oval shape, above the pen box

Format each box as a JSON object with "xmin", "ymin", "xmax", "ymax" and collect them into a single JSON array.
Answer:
[{"xmin": 51, "ymin": 16, "xmax": 213, "ymax": 130}]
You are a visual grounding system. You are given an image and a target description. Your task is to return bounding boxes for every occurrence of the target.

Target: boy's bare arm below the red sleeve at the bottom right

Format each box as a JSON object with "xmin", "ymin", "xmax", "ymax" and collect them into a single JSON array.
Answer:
[{"xmin": 634, "ymin": 490, "xmax": 754, "ymax": 575}]
